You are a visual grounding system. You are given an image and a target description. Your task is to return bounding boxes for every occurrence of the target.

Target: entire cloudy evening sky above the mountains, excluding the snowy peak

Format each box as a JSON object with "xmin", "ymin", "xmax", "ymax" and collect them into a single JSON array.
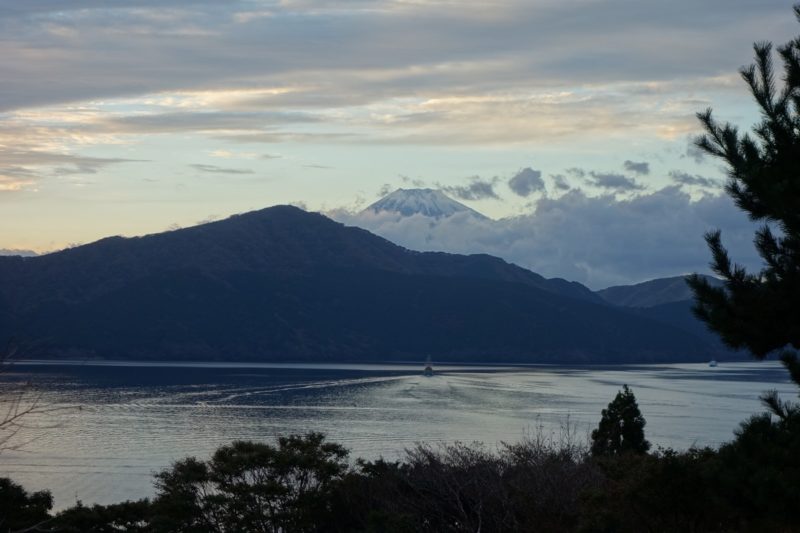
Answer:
[{"xmin": 0, "ymin": 0, "xmax": 798, "ymax": 288}]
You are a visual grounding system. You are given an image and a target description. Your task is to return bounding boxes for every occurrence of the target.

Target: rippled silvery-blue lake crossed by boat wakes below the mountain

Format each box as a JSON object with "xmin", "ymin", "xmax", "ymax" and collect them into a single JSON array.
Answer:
[{"xmin": 0, "ymin": 362, "xmax": 796, "ymax": 508}]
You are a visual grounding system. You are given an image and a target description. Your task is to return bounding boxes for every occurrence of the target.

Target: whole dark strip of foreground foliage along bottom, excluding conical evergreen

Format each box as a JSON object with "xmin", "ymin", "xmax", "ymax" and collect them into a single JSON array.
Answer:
[{"xmin": 0, "ymin": 412, "xmax": 800, "ymax": 533}]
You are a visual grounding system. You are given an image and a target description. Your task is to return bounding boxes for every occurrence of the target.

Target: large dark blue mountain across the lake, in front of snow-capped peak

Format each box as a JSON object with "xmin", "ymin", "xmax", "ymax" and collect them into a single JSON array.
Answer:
[{"xmin": 0, "ymin": 206, "xmax": 724, "ymax": 362}]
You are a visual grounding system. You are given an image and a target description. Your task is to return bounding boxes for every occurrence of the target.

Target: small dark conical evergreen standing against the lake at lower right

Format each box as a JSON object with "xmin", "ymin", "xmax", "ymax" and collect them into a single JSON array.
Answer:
[{"xmin": 592, "ymin": 385, "xmax": 650, "ymax": 455}]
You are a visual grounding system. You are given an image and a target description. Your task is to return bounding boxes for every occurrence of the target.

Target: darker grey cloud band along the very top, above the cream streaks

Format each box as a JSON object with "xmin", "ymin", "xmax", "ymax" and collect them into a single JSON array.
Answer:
[{"xmin": 0, "ymin": 0, "xmax": 795, "ymax": 113}]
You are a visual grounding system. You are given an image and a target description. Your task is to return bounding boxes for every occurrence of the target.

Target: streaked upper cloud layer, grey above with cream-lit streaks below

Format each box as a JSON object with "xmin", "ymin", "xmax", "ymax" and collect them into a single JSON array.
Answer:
[{"xmin": 0, "ymin": 0, "xmax": 795, "ymax": 154}]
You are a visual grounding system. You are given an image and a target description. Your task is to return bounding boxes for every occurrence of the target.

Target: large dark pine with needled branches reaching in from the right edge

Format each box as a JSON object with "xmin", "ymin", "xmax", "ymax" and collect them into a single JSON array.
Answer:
[{"xmin": 688, "ymin": 5, "xmax": 800, "ymax": 385}]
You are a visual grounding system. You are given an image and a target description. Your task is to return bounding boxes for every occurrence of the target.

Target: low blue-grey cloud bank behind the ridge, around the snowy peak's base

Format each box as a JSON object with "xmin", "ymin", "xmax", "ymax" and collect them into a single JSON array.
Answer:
[{"xmin": 330, "ymin": 186, "xmax": 760, "ymax": 289}]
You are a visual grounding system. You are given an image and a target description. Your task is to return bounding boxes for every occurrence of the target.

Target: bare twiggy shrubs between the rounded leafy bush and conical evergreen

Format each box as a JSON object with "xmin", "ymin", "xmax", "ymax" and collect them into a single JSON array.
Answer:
[{"xmin": 334, "ymin": 428, "xmax": 600, "ymax": 532}]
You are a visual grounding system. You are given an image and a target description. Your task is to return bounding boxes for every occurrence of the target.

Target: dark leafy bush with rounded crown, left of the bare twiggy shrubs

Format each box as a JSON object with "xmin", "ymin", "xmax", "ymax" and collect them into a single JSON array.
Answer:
[{"xmin": 153, "ymin": 433, "xmax": 348, "ymax": 532}]
